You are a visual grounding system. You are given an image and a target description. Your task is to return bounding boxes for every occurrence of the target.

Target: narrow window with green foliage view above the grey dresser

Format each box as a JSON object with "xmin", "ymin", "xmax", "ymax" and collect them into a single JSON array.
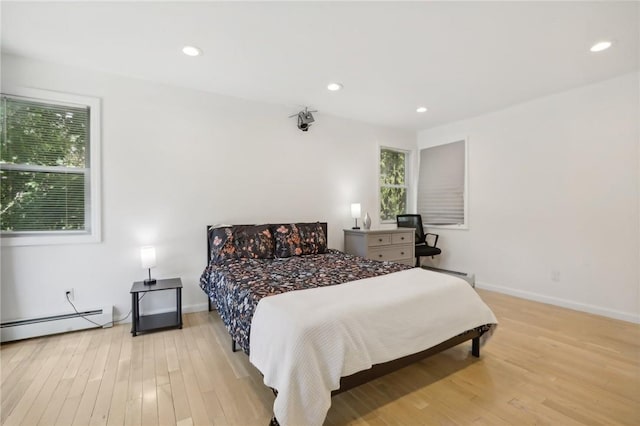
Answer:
[{"xmin": 380, "ymin": 148, "xmax": 408, "ymax": 223}]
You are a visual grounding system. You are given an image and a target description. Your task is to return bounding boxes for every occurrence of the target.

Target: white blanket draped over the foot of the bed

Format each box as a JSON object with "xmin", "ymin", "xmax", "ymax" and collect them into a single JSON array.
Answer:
[{"xmin": 250, "ymin": 268, "xmax": 497, "ymax": 426}]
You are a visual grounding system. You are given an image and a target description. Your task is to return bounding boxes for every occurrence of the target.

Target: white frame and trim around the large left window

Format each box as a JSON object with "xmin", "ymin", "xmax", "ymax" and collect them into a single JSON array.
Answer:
[{"xmin": 0, "ymin": 88, "xmax": 102, "ymax": 247}]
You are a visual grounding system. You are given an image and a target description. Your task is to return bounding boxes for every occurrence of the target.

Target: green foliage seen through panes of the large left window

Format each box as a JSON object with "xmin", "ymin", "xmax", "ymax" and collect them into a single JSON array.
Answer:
[{"xmin": 0, "ymin": 96, "xmax": 89, "ymax": 232}]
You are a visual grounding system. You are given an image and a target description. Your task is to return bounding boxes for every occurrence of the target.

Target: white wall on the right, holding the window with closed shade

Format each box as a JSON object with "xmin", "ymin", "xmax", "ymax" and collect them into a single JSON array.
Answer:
[{"xmin": 418, "ymin": 73, "xmax": 640, "ymax": 322}]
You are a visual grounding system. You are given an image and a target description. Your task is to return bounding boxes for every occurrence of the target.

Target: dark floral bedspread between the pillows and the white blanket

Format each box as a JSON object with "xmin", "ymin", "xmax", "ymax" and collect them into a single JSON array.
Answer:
[{"xmin": 200, "ymin": 250, "xmax": 411, "ymax": 355}]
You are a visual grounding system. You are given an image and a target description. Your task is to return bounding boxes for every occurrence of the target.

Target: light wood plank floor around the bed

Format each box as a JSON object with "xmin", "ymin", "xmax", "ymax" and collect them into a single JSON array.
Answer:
[{"xmin": 0, "ymin": 291, "xmax": 640, "ymax": 426}]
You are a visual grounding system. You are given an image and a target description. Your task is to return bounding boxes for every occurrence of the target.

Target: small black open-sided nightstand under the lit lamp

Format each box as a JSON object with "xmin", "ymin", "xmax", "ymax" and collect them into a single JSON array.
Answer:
[{"xmin": 131, "ymin": 278, "xmax": 182, "ymax": 336}]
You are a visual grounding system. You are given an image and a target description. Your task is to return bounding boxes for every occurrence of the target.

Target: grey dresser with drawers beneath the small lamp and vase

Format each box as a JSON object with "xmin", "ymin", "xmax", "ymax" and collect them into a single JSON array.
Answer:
[{"xmin": 344, "ymin": 228, "xmax": 416, "ymax": 266}]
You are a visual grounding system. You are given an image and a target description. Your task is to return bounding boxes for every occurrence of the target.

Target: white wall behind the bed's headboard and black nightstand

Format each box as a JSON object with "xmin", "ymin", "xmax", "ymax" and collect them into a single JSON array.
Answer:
[{"xmin": 1, "ymin": 56, "xmax": 416, "ymax": 320}]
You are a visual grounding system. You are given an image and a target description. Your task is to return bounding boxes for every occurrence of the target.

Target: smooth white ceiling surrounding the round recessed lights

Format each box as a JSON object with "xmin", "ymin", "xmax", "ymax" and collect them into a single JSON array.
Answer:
[{"xmin": 1, "ymin": 1, "xmax": 640, "ymax": 129}]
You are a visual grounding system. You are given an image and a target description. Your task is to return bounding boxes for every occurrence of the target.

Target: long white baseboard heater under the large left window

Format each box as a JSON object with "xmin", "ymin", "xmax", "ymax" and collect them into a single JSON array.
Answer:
[{"xmin": 0, "ymin": 306, "xmax": 113, "ymax": 342}]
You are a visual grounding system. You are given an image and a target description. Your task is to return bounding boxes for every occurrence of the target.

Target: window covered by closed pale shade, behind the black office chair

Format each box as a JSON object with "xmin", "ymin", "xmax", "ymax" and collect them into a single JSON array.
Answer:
[{"xmin": 418, "ymin": 140, "xmax": 467, "ymax": 228}]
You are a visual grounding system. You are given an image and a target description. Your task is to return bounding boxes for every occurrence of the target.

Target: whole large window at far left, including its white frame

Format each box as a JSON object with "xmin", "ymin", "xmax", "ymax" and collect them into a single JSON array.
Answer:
[{"xmin": 0, "ymin": 90, "xmax": 100, "ymax": 245}]
